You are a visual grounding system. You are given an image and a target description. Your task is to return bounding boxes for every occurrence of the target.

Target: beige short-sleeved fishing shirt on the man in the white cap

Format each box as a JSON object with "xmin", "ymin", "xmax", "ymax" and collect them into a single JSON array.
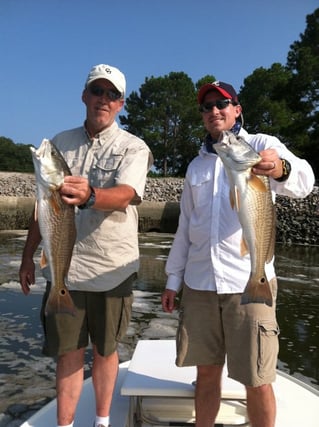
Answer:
[{"xmin": 52, "ymin": 122, "xmax": 153, "ymax": 292}]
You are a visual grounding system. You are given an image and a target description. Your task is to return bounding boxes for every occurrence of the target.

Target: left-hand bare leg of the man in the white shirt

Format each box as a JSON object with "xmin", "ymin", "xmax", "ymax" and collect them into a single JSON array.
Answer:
[{"xmin": 195, "ymin": 365, "xmax": 223, "ymax": 427}]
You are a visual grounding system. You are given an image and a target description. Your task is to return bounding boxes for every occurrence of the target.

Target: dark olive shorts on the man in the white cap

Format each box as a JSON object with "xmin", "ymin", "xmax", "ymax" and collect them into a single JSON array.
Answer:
[{"xmin": 41, "ymin": 277, "xmax": 135, "ymax": 357}]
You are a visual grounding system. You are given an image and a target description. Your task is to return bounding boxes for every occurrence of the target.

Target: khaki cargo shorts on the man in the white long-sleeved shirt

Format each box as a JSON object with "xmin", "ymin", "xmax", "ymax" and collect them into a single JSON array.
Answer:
[{"xmin": 176, "ymin": 279, "xmax": 279, "ymax": 387}]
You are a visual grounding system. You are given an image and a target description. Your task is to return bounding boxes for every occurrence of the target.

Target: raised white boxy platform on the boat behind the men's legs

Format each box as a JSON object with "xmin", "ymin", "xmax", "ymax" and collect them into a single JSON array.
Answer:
[{"xmin": 121, "ymin": 340, "xmax": 248, "ymax": 427}]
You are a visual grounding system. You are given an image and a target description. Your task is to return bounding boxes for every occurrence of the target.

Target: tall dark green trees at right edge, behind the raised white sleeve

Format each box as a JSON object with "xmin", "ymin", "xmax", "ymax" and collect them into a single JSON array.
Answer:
[{"xmin": 239, "ymin": 9, "xmax": 319, "ymax": 177}]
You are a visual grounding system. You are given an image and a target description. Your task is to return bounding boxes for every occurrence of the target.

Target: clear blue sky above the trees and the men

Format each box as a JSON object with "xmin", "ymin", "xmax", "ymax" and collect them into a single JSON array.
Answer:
[{"xmin": 0, "ymin": 0, "xmax": 319, "ymax": 146}]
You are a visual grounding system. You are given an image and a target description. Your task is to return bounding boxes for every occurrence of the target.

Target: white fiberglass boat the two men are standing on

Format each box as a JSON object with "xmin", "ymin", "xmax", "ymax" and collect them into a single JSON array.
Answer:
[{"xmin": 21, "ymin": 340, "xmax": 319, "ymax": 427}]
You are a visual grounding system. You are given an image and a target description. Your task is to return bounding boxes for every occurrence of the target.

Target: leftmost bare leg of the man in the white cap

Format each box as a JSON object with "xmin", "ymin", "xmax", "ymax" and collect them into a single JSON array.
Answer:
[{"xmin": 56, "ymin": 348, "xmax": 85, "ymax": 426}]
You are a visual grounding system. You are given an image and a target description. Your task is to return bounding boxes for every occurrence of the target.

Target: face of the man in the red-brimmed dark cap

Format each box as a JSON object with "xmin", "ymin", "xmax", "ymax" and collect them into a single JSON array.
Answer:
[{"xmin": 202, "ymin": 90, "xmax": 241, "ymax": 139}]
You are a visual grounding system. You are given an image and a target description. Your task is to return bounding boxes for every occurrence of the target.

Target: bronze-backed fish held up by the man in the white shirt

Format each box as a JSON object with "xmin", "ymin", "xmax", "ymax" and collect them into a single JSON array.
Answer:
[{"xmin": 214, "ymin": 131, "xmax": 276, "ymax": 306}]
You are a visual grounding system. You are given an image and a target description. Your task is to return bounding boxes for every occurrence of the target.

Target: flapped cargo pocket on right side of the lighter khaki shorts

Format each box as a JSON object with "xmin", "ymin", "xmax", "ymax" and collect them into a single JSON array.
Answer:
[{"xmin": 258, "ymin": 320, "xmax": 279, "ymax": 378}]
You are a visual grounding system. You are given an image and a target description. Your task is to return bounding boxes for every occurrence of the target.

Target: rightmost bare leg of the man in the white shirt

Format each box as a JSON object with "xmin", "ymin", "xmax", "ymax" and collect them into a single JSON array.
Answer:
[{"xmin": 246, "ymin": 384, "xmax": 276, "ymax": 427}]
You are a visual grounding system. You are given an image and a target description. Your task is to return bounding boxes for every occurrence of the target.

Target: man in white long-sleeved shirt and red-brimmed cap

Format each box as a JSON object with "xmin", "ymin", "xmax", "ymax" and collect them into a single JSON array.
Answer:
[{"xmin": 162, "ymin": 81, "xmax": 314, "ymax": 427}]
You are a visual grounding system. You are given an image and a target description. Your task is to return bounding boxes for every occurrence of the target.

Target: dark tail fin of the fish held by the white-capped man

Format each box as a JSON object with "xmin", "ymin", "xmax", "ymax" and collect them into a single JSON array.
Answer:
[{"xmin": 45, "ymin": 286, "xmax": 76, "ymax": 316}]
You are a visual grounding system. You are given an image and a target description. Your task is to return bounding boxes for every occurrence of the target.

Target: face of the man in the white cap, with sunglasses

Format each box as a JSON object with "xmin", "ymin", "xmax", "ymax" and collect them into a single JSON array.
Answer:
[{"xmin": 82, "ymin": 79, "xmax": 124, "ymax": 135}]
